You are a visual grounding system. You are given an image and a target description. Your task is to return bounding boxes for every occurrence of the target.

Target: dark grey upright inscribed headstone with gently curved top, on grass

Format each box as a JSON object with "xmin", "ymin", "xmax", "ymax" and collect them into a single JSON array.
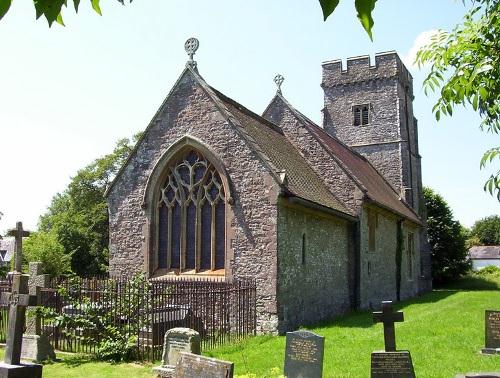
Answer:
[{"xmin": 285, "ymin": 331, "xmax": 325, "ymax": 378}]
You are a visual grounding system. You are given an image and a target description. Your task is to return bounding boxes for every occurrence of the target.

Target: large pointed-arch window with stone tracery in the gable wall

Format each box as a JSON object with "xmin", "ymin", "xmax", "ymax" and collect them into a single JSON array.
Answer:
[{"xmin": 157, "ymin": 149, "xmax": 226, "ymax": 271}]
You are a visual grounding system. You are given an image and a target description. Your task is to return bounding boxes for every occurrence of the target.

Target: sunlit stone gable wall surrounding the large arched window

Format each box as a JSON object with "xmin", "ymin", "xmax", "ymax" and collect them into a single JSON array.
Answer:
[{"xmin": 108, "ymin": 73, "xmax": 278, "ymax": 332}]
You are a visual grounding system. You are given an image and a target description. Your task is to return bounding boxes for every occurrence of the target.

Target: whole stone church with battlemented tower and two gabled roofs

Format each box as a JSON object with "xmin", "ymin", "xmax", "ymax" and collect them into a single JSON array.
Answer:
[{"xmin": 107, "ymin": 39, "xmax": 431, "ymax": 333}]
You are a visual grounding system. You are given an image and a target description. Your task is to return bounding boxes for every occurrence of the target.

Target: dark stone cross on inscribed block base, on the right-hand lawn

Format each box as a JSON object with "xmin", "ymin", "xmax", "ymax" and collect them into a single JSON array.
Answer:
[{"xmin": 370, "ymin": 301, "xmax": 415, "ymax": 378}]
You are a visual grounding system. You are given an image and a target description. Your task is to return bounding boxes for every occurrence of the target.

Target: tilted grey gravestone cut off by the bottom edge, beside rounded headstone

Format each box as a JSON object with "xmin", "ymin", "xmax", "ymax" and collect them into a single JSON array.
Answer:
[{"xmin": 175, "ymin": 352, "xmax": 234, "ymax": 378}]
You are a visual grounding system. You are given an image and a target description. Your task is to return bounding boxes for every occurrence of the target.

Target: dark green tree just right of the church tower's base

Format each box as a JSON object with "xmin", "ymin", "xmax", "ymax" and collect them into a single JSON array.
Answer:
[{"xmin": 423, "ymin": 188, "xmax": 471, "ymax": 284}]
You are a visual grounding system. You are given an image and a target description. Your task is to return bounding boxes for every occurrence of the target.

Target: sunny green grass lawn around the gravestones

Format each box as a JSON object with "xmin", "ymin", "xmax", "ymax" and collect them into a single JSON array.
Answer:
[{"xmin": 0, "ymin": 274, "xmax": 500, "ymax": 378}]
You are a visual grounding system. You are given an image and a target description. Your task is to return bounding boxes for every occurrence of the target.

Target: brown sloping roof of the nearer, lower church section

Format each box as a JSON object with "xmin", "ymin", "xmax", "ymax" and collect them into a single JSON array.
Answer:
[{"xmin": 206, "ymin": 87, "xmax": 351, "ymax": 215}]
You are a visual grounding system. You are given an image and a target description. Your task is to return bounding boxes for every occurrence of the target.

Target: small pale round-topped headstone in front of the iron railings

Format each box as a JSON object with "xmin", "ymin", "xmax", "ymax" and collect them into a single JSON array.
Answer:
[{"xmin": 153, "ymin": 327, "xmax": 201, "ymax": 377}]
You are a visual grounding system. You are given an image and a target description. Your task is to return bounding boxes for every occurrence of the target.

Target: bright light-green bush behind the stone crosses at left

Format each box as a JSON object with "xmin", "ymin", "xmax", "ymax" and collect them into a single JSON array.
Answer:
[{"xmin": 23, "ymin": 231, "xmax": 71, "ymax": 277}]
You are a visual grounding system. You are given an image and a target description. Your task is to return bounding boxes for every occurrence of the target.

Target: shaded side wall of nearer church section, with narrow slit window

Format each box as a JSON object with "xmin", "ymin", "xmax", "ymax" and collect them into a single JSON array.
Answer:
[{"xmin": 278, "ymin": 199, "xmax": 350, "ymax": 333}]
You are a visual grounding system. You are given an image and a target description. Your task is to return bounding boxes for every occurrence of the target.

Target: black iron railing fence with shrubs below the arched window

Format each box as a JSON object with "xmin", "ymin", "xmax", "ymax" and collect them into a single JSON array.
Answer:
[{"xmin": 35, "ymin": 278, "xmax": 256, "ymax": 361}]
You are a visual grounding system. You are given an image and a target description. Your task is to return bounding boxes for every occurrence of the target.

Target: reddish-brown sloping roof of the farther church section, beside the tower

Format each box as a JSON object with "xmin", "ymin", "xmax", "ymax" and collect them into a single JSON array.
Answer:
[{"xmin": 266, "ymin": 93, "xmax": 421, "ymax": 224}]
